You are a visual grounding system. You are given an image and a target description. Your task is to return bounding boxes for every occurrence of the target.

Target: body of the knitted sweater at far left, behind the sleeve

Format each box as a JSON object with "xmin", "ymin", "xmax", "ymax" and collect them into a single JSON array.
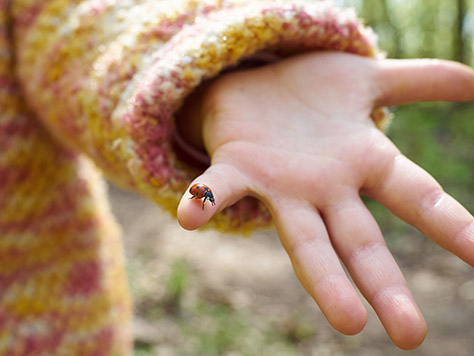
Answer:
[{"xmin": 0, "ymin": 1, "xmax": 132, "ymax": 356}]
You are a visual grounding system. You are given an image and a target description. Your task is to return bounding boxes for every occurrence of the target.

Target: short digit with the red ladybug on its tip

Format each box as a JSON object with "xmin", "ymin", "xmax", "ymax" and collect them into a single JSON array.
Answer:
[{"xmin": 178, "ymin": 163, "xmax": 249, "ymax": 230}]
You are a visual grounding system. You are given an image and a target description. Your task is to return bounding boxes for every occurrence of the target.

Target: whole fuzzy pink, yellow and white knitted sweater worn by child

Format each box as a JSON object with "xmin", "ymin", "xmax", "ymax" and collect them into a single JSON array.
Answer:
[{"xmin": 0, "ymin": 0, "xmax": 383, "ymax": 355}]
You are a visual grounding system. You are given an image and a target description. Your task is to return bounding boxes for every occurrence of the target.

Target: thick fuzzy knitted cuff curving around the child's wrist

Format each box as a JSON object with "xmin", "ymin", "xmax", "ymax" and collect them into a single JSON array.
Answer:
[{"xmin": 114, "ymin": 1, "xmax": 383, "ymax": 229}]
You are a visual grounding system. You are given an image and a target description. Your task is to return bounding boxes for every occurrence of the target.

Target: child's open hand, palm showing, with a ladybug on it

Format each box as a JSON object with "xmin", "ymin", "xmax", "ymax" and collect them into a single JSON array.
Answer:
[{"xmin": 178, "ymin": 53, "xmax": 474, "ymax": 349}]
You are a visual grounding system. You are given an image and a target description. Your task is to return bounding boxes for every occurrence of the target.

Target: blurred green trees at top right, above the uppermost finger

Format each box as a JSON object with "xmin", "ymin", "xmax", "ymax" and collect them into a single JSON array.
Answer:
[{"xmin": 338, "ymin": 0, "xmax": 474, "ymax": 65}]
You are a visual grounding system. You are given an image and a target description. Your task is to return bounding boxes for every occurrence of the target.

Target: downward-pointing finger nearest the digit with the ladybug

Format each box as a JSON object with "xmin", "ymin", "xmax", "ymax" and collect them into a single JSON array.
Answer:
[{"xmin": 271, "ymin": 200, "xmax": 367, "ymax": 335}]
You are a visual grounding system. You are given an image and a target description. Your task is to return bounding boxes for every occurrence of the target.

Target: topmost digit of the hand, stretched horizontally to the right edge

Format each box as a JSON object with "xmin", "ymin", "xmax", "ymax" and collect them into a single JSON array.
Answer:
[{"xmin": 376, "ymin": 59, "xmax": 474, "ymax": 106}]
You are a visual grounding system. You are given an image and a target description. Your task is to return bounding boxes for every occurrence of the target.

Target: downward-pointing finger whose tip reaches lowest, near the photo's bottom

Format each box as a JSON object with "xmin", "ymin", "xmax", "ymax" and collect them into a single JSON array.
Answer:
[{"xmin": 323, "ymin": 193, "xmax": 426, "ymax": 349}]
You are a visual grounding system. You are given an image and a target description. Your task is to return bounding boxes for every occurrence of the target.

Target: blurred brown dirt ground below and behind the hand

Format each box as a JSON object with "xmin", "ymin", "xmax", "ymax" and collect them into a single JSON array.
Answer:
[{"xmin": 110, "ymin": 187, "xmax": 474, "ymax": 356}]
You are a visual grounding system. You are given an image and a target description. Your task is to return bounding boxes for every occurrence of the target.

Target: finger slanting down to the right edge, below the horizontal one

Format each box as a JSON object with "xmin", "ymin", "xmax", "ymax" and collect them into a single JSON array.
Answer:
[{"xmin": 366, "ymin": 154, "xmax": 474, "ymax": 266}]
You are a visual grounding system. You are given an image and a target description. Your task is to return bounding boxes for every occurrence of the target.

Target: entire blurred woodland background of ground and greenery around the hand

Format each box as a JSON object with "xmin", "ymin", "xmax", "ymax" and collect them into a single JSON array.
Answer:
[{"xmin": 110, "ymin": 0, "xmax": 474, "ymax": 356}]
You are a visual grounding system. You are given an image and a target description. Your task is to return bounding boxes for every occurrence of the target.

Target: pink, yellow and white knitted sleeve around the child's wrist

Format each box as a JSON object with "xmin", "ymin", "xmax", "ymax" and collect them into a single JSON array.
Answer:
[{"xmin": 13, "ymin": 0, "xmax": 384, "ymax": 229}]
